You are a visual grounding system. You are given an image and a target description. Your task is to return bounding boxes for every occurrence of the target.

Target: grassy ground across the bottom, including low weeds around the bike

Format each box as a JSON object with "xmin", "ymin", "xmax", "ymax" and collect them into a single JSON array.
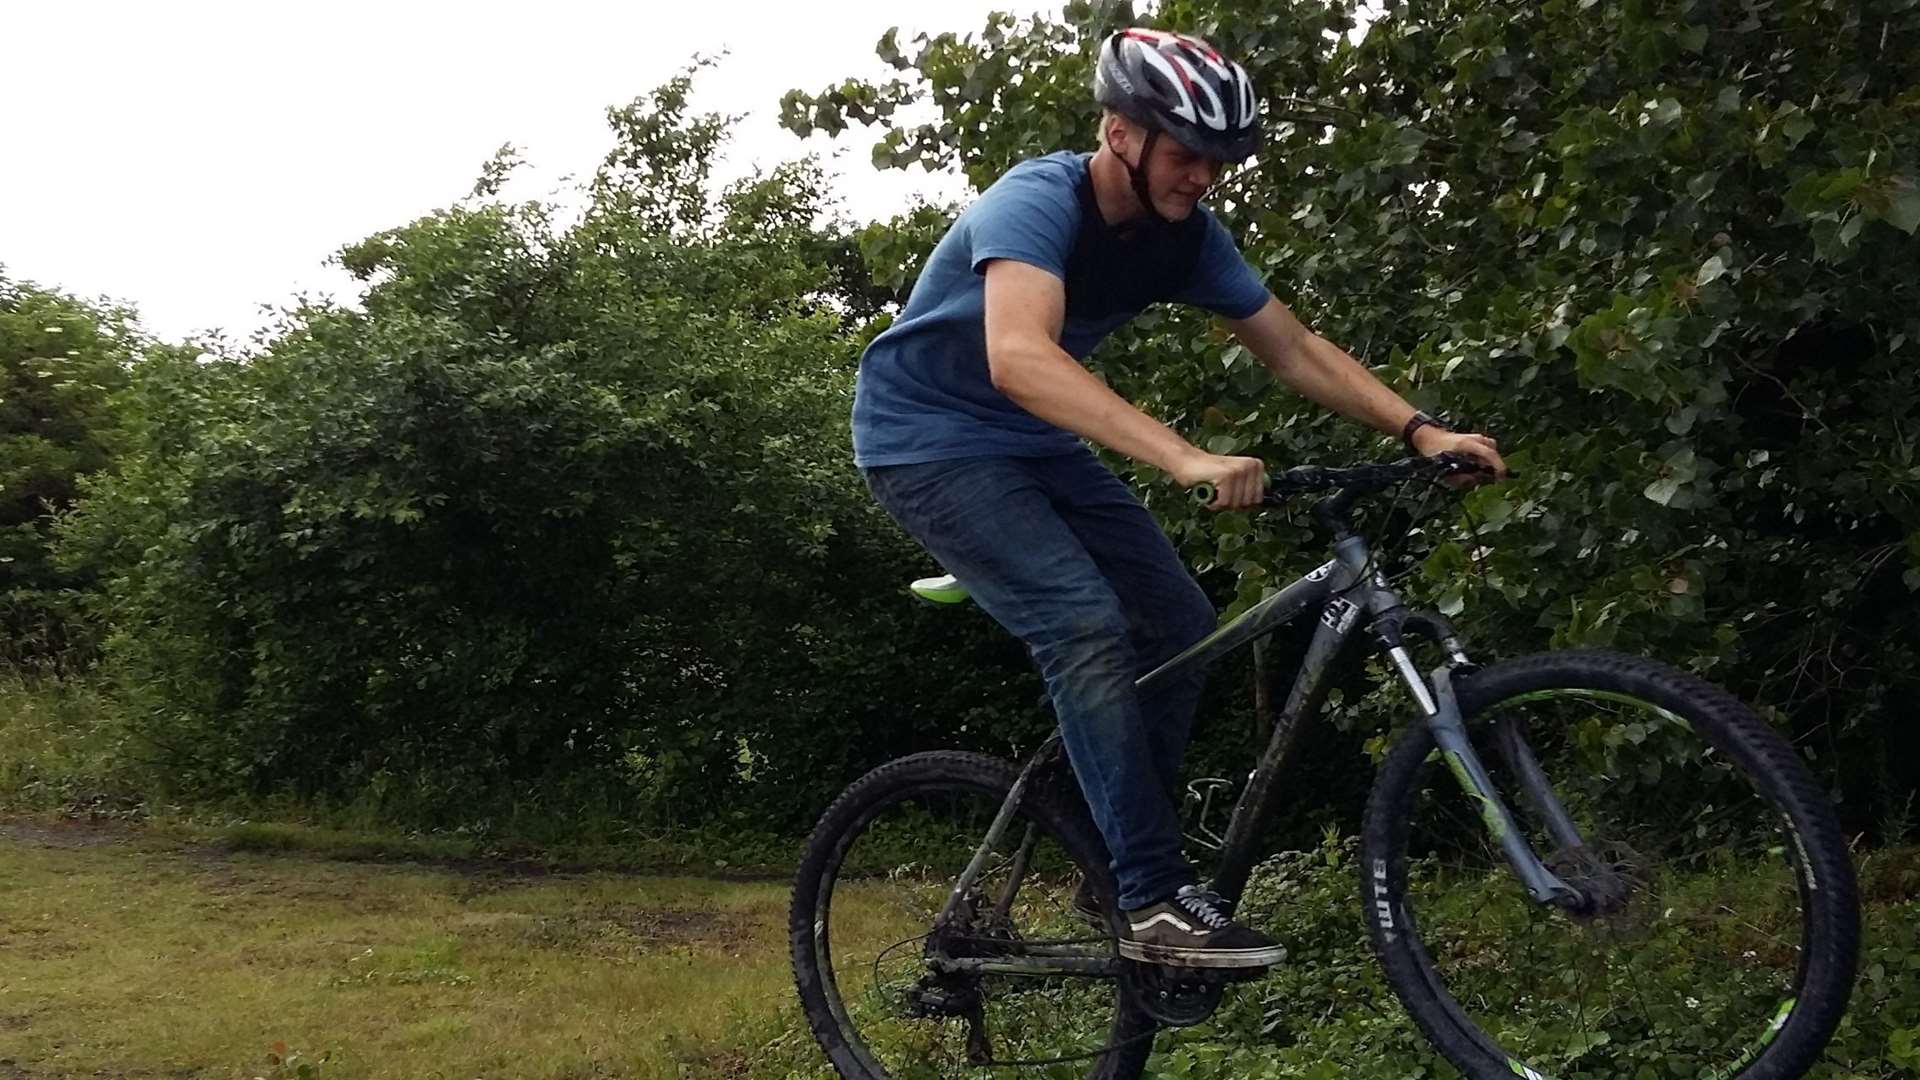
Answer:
[{"xmin": 11, "ymin": 675, "xmax": 1920, "ymax": 1080}]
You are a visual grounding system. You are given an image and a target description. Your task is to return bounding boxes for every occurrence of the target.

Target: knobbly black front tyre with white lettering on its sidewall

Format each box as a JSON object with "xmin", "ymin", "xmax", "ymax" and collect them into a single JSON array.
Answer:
[{"xmin": 1361, "ymin": 651, "xmax": 1859, "ymax": 1080}]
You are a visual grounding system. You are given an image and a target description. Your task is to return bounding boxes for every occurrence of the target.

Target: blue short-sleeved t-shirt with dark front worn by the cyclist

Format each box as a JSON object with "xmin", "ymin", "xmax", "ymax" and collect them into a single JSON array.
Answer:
[{"xmin": 852, "ymin": 152, "xmax": 1267, "ymax": 467}]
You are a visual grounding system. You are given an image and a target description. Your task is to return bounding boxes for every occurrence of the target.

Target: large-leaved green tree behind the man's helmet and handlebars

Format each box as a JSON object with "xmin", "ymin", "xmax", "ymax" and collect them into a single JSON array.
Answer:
[{"xmin": 783, "ymin": 0, "xmax": 1920, "ymax": 830}]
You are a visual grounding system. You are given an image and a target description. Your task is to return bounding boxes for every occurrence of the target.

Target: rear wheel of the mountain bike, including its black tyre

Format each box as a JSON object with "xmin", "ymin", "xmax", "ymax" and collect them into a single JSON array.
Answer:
[{"xmin": 789, "ymin": 751, "xmax": 1154, "ymax": 1080}]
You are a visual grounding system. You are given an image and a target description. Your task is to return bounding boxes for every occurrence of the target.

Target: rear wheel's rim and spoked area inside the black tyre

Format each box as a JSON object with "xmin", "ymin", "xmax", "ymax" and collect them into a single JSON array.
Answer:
[{"xmin": 814, "ymin": 782, "xmax": 1119, "ymax": 1080}]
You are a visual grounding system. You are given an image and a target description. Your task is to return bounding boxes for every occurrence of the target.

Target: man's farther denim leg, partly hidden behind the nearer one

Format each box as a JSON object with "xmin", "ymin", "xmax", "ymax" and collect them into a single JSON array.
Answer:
[{"xmin": 1043, "ymin": 454, "xmax": 1219, "ymax": 805}]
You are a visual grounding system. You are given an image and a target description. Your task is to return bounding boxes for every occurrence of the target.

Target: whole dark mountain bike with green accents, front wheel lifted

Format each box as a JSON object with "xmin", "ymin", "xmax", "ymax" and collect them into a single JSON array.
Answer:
[{"xmin": 789, "ymin": 455, "xmax": 1859, "ymax": 1080}]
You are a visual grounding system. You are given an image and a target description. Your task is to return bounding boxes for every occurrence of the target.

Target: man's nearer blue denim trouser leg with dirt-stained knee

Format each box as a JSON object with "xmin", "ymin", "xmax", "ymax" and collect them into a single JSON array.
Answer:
[{"xmin": 866, "ymin": 449, "xmax": 1198, "ymax": 907}]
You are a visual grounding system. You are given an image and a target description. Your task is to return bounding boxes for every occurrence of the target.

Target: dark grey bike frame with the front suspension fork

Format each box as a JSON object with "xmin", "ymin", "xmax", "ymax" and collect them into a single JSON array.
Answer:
[{"xmin": 929, "ymin": 534, "xmax": 1584, "ymax": 976}]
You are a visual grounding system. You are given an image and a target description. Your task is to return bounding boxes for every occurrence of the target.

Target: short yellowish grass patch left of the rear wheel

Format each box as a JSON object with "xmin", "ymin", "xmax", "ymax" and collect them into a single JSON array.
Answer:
[{"xmin": 0, "ymin": 817, "xmax": 797, "ymax": 1080}]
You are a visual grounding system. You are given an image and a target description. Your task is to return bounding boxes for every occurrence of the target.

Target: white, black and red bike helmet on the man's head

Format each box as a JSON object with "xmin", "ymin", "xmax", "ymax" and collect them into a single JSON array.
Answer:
[{"xmin": 1092, "ymin": 27, "xmax": 1260, "ymax": 161}]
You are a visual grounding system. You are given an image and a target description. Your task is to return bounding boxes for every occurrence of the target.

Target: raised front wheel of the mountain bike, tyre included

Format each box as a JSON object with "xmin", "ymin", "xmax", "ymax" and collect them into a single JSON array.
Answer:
[{"xmin": 1361, "ymin": 651, "xmax": 1859, "ymax": 1080}]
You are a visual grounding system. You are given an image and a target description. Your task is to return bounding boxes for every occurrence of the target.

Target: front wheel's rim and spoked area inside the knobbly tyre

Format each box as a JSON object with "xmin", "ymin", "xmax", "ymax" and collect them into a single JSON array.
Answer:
[{"xmin": 1394, "ymin": 688, "xmax": 1814, "ymax": 1080}]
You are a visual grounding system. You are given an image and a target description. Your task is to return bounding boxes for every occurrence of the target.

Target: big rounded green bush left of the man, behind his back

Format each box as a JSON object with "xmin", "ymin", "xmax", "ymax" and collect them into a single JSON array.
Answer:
[{"xmin": 63, "ymin": 79, "xmax": 1041, "ymax": 832}]
